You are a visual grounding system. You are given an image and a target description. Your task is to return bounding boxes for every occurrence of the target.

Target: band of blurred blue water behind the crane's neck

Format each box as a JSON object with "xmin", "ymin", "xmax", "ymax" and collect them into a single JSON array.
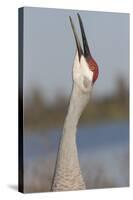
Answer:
[{"xmin": 24, "ymin": 121, "xmax": 129, "ymax": 160}]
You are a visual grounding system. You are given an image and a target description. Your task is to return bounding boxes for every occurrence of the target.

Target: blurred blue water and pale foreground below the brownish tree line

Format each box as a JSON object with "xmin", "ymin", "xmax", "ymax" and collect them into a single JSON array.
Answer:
[{"xmin": 24, "ymin": 121, "xmax": 129, "ymax": 189}]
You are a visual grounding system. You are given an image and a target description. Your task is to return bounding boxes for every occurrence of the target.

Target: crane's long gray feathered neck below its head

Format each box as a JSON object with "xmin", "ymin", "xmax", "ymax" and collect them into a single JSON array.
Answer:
[{"xmin": 52, "ymin": 84, "xmax": 89, "ymax": 191}]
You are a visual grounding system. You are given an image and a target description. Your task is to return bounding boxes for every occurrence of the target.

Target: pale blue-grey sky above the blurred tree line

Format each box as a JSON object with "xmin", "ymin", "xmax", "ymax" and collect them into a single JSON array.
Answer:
[{"xmin": 24, "ymin": 7, "xmax": 129, "ymax": 100}]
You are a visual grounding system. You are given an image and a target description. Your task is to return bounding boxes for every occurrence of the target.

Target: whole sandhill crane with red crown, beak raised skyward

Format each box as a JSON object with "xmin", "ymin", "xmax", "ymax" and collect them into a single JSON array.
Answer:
[{"xmin": 51, "ymin": 14, "xmax": 98, "ymax": 191}]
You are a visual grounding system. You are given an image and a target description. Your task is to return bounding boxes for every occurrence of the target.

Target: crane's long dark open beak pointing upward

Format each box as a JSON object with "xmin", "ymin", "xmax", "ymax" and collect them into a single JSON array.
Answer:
[{"xmin": 69, "ymin": 14, "xmax": 91, "ymax": 59}]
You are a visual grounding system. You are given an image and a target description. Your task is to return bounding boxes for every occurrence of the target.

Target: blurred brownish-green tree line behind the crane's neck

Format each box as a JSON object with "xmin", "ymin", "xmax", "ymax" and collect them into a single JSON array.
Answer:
[{"xmin": 24, "ymin": 77, "xmax": 129, "ymax": 129}]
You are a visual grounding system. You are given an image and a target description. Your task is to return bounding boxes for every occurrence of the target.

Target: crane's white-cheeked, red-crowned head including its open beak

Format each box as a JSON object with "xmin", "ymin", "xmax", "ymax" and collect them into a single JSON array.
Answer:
[{"xmin": 69, "ymin": 14, "xmax": 99, "ymax": 91}]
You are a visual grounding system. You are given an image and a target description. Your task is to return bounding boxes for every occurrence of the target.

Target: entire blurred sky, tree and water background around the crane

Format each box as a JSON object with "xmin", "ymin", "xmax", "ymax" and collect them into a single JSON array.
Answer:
[{"xmin": 24, "ymin": 7, "xmax": 129, "ymax": 192}]
